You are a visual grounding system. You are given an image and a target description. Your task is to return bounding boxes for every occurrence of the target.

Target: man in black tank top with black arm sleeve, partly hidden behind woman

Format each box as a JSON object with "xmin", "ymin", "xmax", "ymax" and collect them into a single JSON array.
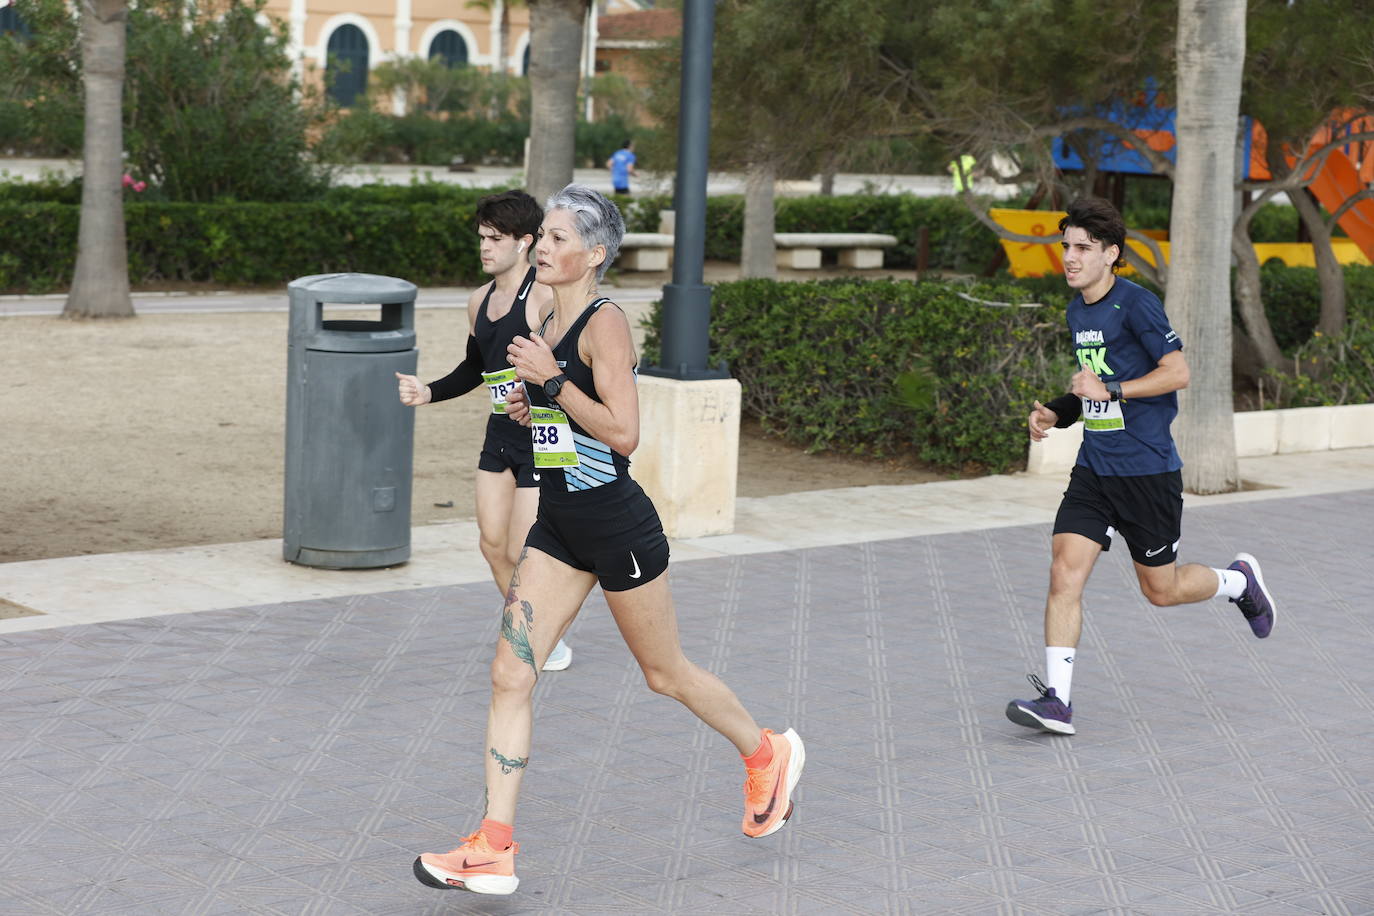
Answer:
[{"xmin": 396, "ymin": 191, "xmax": 573, "ymax": 672}]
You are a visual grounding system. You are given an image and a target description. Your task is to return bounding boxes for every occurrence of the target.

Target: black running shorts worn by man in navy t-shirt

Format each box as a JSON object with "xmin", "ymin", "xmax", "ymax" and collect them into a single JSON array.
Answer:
[{"xmin": 1054, "ymin": 464, "xmax": 1183, "ymax": 566}]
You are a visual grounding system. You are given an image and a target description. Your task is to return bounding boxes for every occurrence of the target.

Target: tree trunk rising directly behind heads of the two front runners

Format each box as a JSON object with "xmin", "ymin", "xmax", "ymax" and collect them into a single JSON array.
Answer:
[{"xmin": 525, "ymin": 0, "xmax": 588, "ymax": 203}]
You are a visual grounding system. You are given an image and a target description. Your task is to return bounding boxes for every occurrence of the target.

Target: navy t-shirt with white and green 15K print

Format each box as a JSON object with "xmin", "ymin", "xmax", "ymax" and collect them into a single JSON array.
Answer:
[{"xmin": 1068, "ymin": 277, "xmax": 1183, "ymax": 477}]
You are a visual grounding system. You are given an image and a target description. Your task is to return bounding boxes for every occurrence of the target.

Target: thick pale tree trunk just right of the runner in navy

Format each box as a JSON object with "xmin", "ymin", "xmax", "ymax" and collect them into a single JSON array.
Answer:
[{"xmin": 1168, "ymin": 0, "xmax": 1245, "ymax": 493}]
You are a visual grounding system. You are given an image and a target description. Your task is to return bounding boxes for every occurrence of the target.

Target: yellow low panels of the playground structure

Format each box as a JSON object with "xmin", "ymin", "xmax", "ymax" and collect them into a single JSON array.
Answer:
[{"xmin": 988, "ymin": 207, "xmax": 1370, "ymax": 276}]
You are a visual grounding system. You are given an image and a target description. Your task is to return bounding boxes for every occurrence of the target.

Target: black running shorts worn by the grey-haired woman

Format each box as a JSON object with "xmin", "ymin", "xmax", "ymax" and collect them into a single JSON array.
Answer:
[{"xmin": 525, "ymin": 478, "xmax": 668, "ymax": 592}]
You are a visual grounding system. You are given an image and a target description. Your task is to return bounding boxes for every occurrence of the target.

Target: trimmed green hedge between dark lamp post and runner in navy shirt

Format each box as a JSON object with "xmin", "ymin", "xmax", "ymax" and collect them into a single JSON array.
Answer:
[{"xmin": 644, "ymin": 279, "xmax": 1073, "ymax": 472}]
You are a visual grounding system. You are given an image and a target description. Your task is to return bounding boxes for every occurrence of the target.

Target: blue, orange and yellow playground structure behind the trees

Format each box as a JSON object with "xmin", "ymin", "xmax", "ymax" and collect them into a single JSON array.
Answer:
[{"xmin": 988, "ymin": 93, "xmax": 1374, "ymax": 276}]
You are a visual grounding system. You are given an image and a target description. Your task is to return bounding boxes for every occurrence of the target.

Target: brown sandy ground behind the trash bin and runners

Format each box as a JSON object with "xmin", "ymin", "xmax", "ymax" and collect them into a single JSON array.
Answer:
[{"xmin": 0, "ymin": 309, "xmax": 937, "ymax": 562}]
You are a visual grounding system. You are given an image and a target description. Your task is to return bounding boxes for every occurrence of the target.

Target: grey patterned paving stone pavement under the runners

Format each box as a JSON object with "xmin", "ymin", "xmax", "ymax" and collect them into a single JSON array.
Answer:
[{"xmin": 0, "ymin": 490, "xmax": 1374, "ymax": 916}]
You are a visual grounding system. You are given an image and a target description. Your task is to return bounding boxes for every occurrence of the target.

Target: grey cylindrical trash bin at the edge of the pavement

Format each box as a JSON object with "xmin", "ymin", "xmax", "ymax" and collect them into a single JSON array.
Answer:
[{"xmin": 282, "ymin": 273, "xmax": 419, "ymax": 569}]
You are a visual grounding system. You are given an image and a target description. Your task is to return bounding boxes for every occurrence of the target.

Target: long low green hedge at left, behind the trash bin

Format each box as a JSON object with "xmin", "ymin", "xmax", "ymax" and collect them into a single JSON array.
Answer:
[{"xmin": 0, "ymin": 201, "xmax": 482, "ymax": 293}]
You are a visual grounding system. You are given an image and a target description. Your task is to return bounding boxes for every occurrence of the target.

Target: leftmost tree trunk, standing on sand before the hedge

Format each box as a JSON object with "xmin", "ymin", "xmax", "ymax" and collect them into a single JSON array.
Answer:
[{"xmin": 62, "ymin": 0, "xmax": 133, "ymax": 317}]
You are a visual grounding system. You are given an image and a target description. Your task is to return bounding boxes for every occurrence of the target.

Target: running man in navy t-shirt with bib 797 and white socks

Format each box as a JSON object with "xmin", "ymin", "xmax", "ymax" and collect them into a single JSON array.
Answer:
[{"xmin": 1007, "ymin": 198, "xmax": 1274, "ymax": 735}]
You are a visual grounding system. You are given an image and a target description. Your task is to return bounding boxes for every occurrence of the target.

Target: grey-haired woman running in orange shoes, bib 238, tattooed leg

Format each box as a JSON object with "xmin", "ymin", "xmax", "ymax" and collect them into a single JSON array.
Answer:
[{"xmin": 412, "ymin": 185, "xmax": 807, "ymax": 894}]
